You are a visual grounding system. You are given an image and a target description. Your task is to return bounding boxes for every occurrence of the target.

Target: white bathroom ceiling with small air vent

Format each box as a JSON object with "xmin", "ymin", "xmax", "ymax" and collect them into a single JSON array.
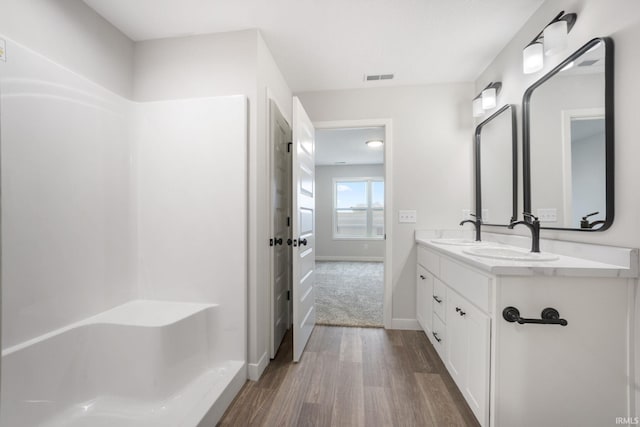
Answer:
[{"xmin": 84, "ymin": 0, "xmax": 544, "ymax": 92}]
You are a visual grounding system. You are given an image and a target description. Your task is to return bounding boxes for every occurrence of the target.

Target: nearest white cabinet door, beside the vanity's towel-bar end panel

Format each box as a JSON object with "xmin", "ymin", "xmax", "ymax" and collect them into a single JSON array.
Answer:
[{"xmin": 463, "ymin": 303, "xmax": 491, "ymax": 426}]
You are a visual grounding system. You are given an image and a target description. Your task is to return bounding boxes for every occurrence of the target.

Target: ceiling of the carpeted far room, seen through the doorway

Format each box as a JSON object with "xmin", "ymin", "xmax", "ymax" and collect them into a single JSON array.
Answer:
[{"xmin": 316, "ymin": 127, "xmax": 384, "ymax": 166}]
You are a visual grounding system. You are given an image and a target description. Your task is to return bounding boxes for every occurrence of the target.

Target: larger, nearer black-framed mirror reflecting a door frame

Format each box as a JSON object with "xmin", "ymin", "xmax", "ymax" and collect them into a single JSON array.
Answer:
[{"xmin": 522, "ymin": 38, "xmax": 614, "ymax": 231}]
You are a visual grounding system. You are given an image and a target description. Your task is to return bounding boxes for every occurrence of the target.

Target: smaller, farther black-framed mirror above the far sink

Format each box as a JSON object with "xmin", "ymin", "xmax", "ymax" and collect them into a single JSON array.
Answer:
[{"xmin": 475, "ymin": 105, "xmax": 518, "ymax": 226}]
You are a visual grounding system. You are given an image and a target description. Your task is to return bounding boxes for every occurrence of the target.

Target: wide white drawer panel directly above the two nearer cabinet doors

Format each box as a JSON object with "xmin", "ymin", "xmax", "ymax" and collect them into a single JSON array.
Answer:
[{"xmin": 440, "ymin": 258, "xmax": 491, "ymax": 313}]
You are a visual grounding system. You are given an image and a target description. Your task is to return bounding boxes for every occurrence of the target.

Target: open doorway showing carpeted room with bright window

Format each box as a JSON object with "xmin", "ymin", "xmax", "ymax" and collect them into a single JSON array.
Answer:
[{"xmin": 314, "ymin": 120, "xmax": 392, "ymax": 327}]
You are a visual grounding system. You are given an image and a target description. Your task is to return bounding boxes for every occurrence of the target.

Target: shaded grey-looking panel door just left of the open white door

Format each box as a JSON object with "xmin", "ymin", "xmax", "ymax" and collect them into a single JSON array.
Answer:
[{"xmin": 269, "ymin": 101, "xmax": 291, "ymax": 359}]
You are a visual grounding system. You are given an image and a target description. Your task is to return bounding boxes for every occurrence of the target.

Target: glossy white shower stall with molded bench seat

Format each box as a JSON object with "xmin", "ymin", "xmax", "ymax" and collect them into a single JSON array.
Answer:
[{"xmin": 0, "ymin": 37, "xmax": 247, "ymax": 427}]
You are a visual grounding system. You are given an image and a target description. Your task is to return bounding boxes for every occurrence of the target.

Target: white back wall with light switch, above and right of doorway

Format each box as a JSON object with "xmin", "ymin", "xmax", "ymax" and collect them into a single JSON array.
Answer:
[{"xmin": 298, "ymin": 83, "xmax": 474, "ymax": 319}]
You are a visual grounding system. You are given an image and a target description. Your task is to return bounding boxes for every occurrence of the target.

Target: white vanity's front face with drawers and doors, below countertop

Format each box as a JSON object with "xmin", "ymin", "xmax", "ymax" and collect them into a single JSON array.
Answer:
[{"xmin": 416, "ymin": 246, "xmax": 491, "ymax": 426}]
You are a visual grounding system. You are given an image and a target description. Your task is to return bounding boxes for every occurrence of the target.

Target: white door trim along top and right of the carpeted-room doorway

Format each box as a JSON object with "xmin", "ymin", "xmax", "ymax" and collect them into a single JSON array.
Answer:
[{"xmin": 313, "ymin": 119, "xmax": 393, "ymax": 329}]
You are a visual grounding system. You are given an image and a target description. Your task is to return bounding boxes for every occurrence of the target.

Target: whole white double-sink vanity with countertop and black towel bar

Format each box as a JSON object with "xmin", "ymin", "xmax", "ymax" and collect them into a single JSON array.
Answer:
[{"xmin": 416, "ymin": 230, "xmax": 638, "ymax": 427}]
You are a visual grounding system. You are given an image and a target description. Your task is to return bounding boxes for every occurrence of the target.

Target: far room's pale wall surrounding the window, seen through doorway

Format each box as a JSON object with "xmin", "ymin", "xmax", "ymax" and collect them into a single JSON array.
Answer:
[{"xmin": 316, "ymin": 165, "xmax": 384, "ymax": 260}]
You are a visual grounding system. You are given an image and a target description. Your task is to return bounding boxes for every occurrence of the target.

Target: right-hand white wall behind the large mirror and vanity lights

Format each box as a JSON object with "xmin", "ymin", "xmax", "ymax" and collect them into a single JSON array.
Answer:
[{"xmin": 476, "ymin": 0, "xmax": 640, "ymax": 415}]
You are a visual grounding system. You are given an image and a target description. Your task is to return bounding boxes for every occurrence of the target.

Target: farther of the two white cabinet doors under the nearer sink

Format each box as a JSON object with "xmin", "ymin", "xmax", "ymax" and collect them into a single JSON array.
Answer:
[{"xmin": 445, "ymin": 291, "xmax": 469, "ymax": 393}]
